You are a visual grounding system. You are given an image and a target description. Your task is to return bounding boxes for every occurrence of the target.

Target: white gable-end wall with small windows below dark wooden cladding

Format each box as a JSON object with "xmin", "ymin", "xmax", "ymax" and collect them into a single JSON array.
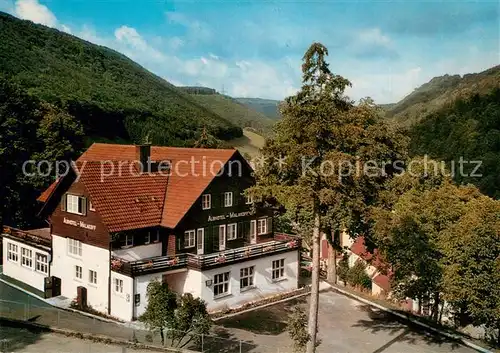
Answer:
[{"xmin": 51, "ymin": 234, "xmax": 110, "ymax": 313}]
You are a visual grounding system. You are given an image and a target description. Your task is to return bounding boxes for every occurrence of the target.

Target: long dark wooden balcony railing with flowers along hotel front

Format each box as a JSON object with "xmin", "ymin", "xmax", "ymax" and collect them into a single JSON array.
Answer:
[{"xmin": 111, "ymin": 233, "xmax": 301, "ymax": 276}]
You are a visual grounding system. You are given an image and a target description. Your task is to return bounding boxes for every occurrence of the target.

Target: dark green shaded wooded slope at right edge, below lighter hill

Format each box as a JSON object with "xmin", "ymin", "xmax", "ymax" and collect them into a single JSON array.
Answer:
[{"xmin": 410, "ymin": 88, "xmax": 500, "ymax": 199}]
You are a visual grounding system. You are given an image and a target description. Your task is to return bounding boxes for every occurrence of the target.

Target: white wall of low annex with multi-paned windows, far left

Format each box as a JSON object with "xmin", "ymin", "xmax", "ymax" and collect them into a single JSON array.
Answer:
[{"xmin": 3, "ymin": 238, "xmax": 50, "ymax": 291}]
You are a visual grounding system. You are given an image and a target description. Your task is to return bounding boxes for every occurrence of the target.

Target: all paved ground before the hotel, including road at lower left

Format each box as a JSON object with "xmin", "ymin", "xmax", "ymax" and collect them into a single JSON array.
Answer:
[{"xmin": 0, "ymin": 283, "xmax": 484, "ymax": 353}]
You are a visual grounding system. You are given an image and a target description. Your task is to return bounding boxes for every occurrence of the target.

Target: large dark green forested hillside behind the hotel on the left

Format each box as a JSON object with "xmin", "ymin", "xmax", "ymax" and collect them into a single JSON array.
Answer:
[{"xmin": 0, "ymin": 13, "xmax": 242, "ymax": 145}]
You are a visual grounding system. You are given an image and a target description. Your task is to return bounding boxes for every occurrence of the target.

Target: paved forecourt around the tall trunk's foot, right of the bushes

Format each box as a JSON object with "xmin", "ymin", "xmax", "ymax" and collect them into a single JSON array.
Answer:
[{"xmin": 222, "ymin": 292, "xmax": 476, "ymax": 353}]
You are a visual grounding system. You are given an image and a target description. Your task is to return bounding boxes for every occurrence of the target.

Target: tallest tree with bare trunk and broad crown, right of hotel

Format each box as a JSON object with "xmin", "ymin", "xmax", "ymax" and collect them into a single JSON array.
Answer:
[{"xmin": 249, "ymin": 43, "xmax": 406, "ymax": 353}]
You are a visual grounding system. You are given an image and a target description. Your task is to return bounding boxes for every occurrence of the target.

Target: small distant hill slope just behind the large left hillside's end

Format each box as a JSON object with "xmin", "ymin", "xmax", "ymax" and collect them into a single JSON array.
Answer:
[{"xmin": 179, "ymin": 86, "xmax": 274, "ymax": 134}]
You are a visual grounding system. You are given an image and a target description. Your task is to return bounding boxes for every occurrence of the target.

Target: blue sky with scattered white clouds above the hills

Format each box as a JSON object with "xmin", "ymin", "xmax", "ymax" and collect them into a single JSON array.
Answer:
[{"xmin": 0, "ymin": 0, "xmax": 500, "ymax": 103}]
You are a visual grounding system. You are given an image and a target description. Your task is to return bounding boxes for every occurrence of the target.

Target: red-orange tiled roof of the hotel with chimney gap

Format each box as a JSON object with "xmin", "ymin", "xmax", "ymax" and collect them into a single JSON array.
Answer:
[{"xmin": 39, "ymin": 143, "xmax": 236, "ymax": 231}]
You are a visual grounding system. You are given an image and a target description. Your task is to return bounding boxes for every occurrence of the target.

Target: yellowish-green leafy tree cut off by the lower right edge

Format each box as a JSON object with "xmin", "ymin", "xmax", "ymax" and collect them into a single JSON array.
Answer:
[{"xmin": 441, "ymin": 196, "xmax": 500, "ymax": 346}]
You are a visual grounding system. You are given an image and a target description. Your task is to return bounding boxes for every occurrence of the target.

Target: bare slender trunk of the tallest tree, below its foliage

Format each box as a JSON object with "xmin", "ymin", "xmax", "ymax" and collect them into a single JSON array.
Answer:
[{"xmin": 307, "ymin": 209, "xmax": 321, "ymax": 353}]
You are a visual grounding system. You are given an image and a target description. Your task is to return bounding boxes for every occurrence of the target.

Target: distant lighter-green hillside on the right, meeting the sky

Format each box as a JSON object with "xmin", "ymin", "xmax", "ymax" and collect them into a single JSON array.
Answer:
[{"xmin": 385, "ymin": 65, "xmax": 500, "ymax": 126}]
